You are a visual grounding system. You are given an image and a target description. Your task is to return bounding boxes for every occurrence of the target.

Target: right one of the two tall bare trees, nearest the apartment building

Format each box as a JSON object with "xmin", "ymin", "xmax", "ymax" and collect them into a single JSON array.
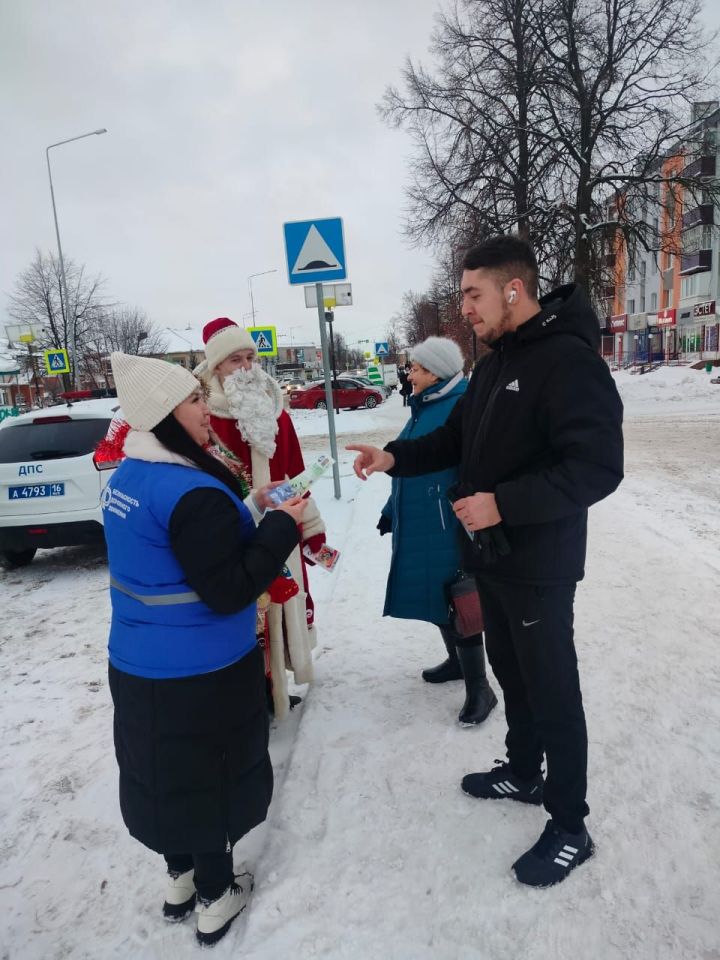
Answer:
[{"xmin": 531, "ymin": 0, "xmax": 720, "ymax": 289}]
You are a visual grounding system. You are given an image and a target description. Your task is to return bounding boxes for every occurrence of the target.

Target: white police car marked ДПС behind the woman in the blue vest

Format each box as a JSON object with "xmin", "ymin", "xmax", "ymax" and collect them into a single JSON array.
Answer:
[{"xmin": 0, "ymin": 399, "xmax": 118, "ymax": 567}]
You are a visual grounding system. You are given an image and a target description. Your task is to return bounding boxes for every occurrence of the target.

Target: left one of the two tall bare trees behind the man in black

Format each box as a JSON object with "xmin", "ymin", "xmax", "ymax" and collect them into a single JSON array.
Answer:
[{"xmin": 380, "ymin": 0, "xmax": 567, "ymax": 277}]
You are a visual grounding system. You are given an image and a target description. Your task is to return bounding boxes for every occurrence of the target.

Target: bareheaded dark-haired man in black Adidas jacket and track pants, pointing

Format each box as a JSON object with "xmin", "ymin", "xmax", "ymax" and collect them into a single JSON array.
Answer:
[{"xmin": 348, "ymin": 236, "xmax": 623, "ymax": 886}]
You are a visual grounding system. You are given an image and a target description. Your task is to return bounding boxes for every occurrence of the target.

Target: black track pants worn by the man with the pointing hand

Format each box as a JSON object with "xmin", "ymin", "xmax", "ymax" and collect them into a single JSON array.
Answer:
[{"xmin": 478, "ymin": 577, "xmax": 589, "ymax": 833}]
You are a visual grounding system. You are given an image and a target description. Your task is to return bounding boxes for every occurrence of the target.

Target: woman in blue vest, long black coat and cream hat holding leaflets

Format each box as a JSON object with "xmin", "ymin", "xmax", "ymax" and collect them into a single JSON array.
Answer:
[{"xmin": 102, "ymin": 353, "xmax": 305, "ymax": 943}]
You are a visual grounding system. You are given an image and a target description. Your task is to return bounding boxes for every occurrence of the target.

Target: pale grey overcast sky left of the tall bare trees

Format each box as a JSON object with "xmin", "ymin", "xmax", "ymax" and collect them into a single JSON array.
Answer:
[{"xmin": 0, "ymin": 0, "xmax": 720, "ymax": 352}]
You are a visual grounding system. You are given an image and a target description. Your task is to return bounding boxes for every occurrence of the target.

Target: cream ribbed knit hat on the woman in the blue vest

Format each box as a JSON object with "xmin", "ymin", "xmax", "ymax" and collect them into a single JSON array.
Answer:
[{"xmin": 110, "ymin": 353, "xmax": 200, "ymax": 430}]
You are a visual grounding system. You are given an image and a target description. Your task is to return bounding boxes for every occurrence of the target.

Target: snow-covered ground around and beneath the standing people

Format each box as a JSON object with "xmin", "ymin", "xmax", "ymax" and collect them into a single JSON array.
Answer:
[{"xmin": 0, "ymin": 368, "xmax": 720, "ymax": 960}]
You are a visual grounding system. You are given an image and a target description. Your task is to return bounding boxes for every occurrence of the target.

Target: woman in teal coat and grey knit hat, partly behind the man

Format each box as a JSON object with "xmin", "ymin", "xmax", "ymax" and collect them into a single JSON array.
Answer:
[{"xmin": 378, "ymin": 337, "xmax": 497, "ymax": 726}]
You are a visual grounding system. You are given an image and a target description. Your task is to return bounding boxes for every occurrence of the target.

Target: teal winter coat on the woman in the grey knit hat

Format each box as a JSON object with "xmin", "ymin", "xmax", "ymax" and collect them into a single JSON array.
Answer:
[{"xmin": 382, "ymin": 375, "xmax": 467, "ymax": 624}]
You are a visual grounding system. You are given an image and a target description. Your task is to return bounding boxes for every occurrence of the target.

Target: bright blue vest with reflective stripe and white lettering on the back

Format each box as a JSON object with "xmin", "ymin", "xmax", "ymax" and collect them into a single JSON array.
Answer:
[{"xmin": 102, "ymin": 459, "xmax": 257, "ymax": 678}]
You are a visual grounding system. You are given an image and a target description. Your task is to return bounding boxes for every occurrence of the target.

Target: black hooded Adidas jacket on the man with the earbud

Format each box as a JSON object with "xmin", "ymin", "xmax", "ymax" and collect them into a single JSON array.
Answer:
[{"xmin": 385, "ymin": 284, "xmax": 623, "ymax": 584}]
